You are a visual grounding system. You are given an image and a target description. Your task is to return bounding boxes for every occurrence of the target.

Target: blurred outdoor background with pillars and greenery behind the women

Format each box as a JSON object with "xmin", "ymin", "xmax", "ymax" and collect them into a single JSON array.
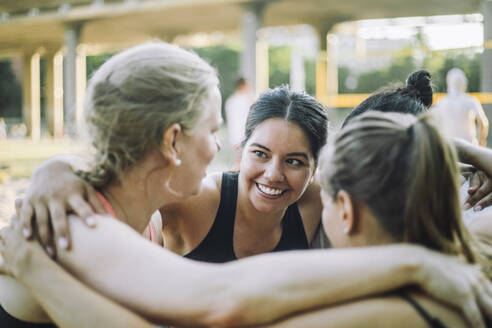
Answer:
[{"xmin": 0, "ymin": 0, "xmax": 492, "ymax": 226}]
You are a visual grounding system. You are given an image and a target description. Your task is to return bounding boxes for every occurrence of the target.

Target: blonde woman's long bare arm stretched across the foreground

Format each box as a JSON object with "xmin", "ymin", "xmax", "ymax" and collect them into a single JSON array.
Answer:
[{"xmin": 2, "ymin": 217, "xmax": 492, "ymax": 327}]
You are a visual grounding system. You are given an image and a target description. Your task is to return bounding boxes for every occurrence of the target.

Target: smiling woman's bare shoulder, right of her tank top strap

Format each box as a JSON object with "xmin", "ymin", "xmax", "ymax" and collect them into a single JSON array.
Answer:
[{"xmin": 297, "ymin": 182, "xmax": 323, "ymax": 243}]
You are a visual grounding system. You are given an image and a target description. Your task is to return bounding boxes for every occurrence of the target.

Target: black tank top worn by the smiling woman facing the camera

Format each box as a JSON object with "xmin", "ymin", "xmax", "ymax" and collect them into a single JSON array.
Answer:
[{"xmin": 185, "ymin": 172, "xmax": 309, "ymax": 263}]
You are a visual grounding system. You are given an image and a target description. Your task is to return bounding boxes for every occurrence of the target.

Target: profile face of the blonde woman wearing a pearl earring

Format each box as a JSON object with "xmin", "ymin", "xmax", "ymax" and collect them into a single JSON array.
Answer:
[{"xmin": 176, "ymin": 87, "xmax": 222, "ymax": 196}]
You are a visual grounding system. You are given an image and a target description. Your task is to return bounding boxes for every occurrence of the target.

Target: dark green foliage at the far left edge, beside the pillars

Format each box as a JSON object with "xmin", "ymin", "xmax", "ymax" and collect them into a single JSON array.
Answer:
[{"xmin": 0, "ymin": 60, "xmax": 22, "ymax": 117}]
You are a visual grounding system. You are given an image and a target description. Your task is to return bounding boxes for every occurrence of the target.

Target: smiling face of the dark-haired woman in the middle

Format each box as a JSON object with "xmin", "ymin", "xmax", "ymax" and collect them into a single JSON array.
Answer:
[{"xmin": 239, "ymin": 118, "xmax": 314, "ymax": 213}]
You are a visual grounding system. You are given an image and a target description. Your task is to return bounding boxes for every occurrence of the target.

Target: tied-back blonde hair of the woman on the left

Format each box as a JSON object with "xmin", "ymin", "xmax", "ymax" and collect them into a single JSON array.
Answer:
[{"xmin": 79, "ymin": 42, "xmax": 219, "ymax": 187}]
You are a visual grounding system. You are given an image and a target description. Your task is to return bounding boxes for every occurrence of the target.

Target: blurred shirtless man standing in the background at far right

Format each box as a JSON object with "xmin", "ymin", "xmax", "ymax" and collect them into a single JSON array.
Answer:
[{"xmin": 433, "ymin": 68, "xmax": 489, "ymax": 146}]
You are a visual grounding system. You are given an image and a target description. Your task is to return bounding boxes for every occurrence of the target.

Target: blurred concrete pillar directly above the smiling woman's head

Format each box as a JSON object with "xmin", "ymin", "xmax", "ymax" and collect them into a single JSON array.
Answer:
[{"xmin": 240, "ymin": 1, "xmax": 268, "ymax": 90}]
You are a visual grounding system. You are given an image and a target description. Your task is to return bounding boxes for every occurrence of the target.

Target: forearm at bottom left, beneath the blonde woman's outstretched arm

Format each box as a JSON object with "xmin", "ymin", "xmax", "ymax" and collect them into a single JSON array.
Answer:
[{"xmin": 15, "ymin": 247, "xmax": 153, "ymax": 328}]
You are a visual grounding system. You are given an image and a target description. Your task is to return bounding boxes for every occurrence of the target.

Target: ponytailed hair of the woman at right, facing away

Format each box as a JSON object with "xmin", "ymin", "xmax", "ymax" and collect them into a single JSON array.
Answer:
[{"xmin": 319, "ymin": 111, "xmax": 490, "ymax": 275}]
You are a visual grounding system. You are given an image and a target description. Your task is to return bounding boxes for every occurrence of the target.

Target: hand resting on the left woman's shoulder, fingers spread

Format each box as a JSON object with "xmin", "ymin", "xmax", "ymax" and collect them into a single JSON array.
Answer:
[{"xmin": 19, "ymin": 155, "xmax": 106, "ymax": 253}]
